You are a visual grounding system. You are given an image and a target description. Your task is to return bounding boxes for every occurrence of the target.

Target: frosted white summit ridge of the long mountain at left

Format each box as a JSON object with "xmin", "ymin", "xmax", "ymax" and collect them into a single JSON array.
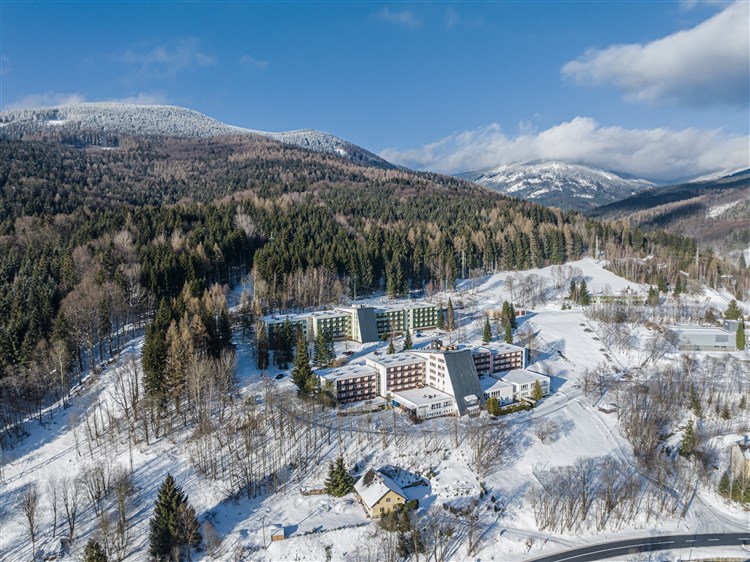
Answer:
[{"xmin": 0, "ymin": 102, "xmax": 395, "ymax": 168}]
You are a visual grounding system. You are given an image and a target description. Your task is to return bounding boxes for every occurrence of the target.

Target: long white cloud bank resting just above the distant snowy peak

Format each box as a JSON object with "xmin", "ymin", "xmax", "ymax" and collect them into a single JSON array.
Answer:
[{"xmin": 380, "ymin": 117, "xmax": 750, "ymax": 180}]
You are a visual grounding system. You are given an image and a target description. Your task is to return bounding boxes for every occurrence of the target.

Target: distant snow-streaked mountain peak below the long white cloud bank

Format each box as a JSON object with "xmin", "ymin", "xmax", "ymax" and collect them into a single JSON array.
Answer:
[{"xmin": 457, "ymin": 161, "xmax": 654, "ymax": 210}]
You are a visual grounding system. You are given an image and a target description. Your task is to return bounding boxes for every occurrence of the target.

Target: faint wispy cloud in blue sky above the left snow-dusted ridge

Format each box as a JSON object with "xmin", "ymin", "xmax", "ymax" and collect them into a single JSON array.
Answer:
[{"xmin": 108, "ymin": 37, "xmax": 216, "ymax": 78}]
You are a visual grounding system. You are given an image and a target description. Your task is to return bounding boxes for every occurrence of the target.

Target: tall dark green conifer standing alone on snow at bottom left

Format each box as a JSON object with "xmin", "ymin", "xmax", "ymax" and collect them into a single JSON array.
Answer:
[{"xmin": 149, "ymin": 474, "xmax": 201, "ymax": 558}]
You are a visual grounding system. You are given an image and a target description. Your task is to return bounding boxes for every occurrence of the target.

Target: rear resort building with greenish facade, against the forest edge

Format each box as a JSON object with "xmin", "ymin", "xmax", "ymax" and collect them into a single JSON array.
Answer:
[{"xmin": 265, "ymin": 302, "xmax": 438, "ymax": 345}]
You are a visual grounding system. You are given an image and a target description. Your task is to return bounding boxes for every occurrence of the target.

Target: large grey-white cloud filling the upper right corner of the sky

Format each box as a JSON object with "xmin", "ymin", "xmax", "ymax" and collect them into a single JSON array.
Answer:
[{"xmin": 562, "ymin": 1, "xmax": 750, "ymax": 107}]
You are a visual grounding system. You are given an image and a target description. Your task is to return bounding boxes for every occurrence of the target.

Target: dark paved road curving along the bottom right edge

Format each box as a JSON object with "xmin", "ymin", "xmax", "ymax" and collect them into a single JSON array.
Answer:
[{"xmin": 529, "ymin": 531, "xmax": 750, "ymax": 562}]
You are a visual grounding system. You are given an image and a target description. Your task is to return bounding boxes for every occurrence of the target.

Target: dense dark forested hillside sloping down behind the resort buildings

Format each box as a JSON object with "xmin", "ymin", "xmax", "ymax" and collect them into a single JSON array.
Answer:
[{"xmin": 0, "ymin": 133, "xmax": 740, "ymax": 427}]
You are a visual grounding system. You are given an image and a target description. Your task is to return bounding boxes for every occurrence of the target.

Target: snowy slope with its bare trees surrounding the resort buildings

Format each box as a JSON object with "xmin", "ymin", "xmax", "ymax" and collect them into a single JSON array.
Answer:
[{"xmin": 0, "ymin": 259, "xmax": 750, "ymax": 561}]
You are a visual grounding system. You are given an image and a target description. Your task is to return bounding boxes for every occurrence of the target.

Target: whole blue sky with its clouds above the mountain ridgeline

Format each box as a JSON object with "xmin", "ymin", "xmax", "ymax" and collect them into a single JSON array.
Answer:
[{"xmin": 0, "ymin": 0, "xmax": 750, "ymax": 179}]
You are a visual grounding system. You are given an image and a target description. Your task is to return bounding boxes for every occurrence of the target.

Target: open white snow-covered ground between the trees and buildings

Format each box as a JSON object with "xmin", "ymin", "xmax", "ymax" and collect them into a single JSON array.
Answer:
[{"xmin": 0, "ymin": 259, "xmax": 747, "ymax": 561}]
